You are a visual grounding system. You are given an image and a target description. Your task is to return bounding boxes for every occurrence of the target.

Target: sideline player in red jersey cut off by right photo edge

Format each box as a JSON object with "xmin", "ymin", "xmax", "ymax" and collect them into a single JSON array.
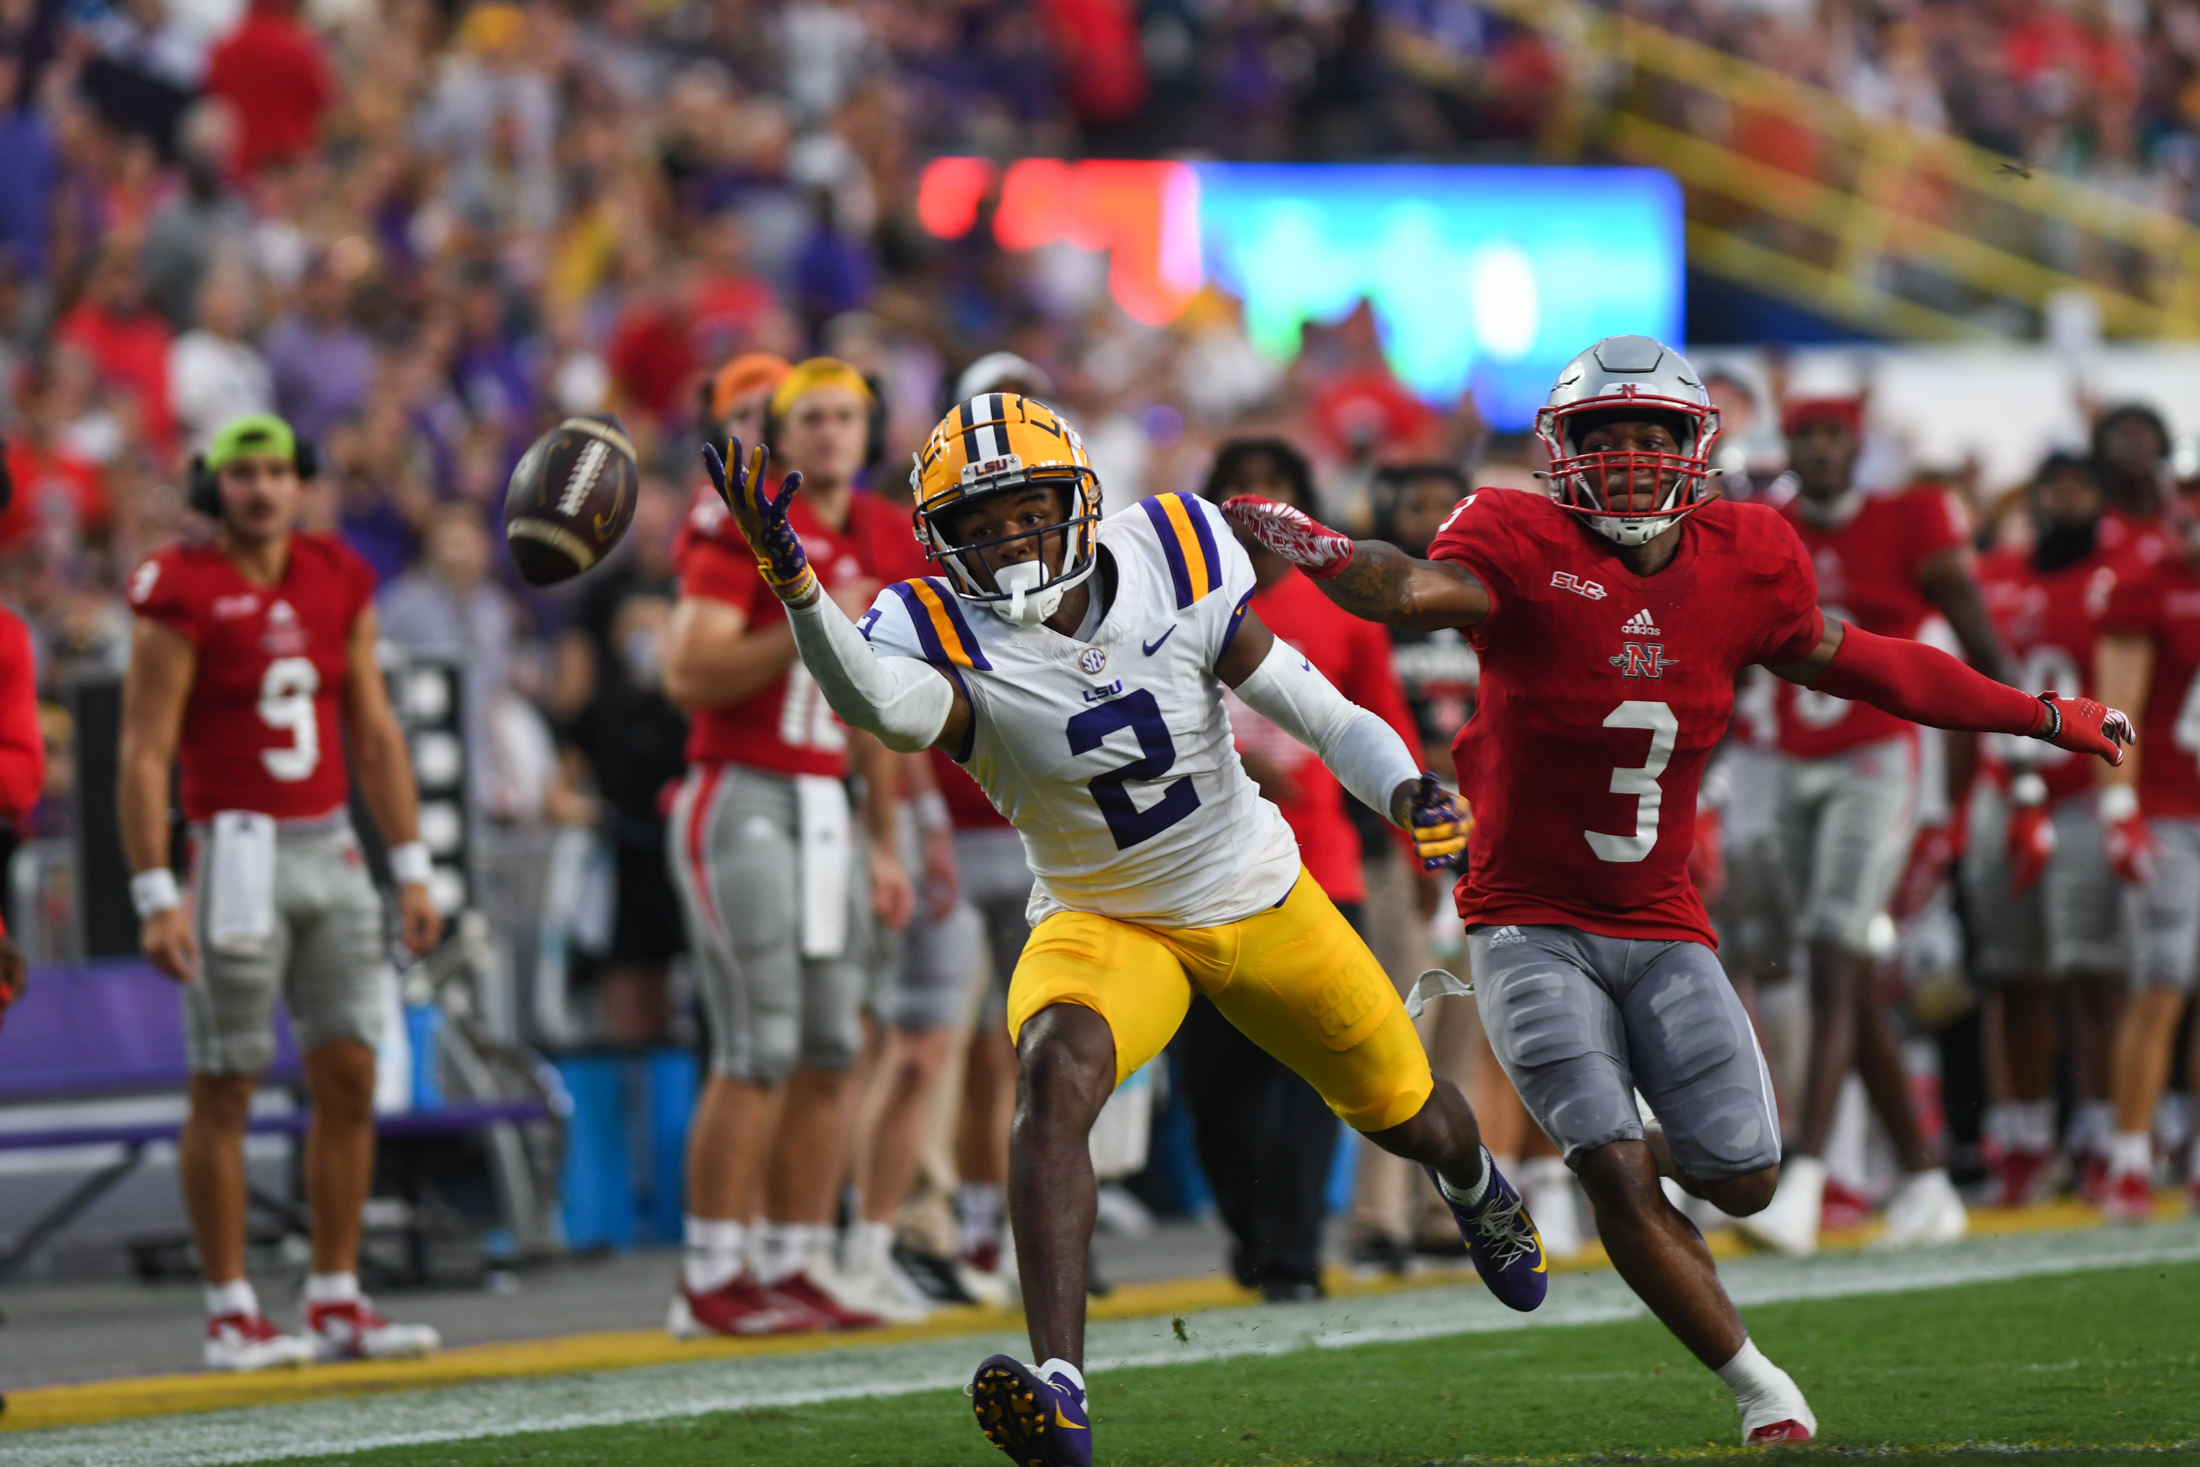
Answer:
[{"xmin": 2094, "ymin": 510, "xmax": 2200, "ymax": 1221}]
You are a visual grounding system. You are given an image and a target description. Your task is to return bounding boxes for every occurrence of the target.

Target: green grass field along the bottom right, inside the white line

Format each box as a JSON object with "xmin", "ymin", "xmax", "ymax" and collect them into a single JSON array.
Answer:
[{"xmin": 240, "ymin": 1262, "xmax": 2200, "ymax": 1467}]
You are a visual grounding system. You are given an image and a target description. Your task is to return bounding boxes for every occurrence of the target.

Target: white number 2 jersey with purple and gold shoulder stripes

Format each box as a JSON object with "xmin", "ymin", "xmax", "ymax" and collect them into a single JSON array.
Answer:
[{"xmin": 858, "ymin": 495, "xmax": 1300, "ymax": 928}]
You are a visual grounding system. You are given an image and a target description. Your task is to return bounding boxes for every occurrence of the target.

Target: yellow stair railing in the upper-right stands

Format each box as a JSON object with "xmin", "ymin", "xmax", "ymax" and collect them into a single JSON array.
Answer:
[{"xmin": 1483, "ymin": 0, "xmax": 2200, "ymax": 337}]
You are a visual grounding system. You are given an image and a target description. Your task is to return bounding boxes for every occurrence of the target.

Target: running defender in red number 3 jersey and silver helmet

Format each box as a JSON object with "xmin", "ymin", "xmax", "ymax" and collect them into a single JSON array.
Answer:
[{"xmin": 1228, "ymin": 337, "xmax": 2130, "ymax": 1441}]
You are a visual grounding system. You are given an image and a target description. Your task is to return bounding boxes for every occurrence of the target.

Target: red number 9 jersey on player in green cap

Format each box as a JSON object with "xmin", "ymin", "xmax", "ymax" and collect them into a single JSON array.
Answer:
[{"xmin": 130, "ymin": 532, "xmax": 374, "ymax": 820}]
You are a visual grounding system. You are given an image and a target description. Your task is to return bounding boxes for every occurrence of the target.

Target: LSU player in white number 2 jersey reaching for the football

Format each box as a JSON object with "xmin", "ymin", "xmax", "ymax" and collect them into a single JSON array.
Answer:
[{"xmin": 704, "ymin": 394, "xmax": 1547, "ymax": 1467}]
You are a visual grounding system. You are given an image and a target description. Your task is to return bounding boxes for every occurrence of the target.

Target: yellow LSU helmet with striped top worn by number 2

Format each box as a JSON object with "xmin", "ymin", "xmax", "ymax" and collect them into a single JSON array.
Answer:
[{"xmin": 909, "ymin": 391, "xmax": 1100, "ymax": 627}]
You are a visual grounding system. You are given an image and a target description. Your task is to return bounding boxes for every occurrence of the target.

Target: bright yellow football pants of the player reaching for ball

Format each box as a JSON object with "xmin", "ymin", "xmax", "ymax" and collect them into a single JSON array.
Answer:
[{"xmin": 1008, "ymin": 871, "xmax": 1432, "ymax": 1130}]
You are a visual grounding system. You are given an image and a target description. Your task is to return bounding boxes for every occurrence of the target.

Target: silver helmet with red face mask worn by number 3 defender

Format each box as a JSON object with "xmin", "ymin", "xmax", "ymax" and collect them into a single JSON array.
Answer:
[{"xmin": 1536, "ymin": 337, "xmax": 1718, "ymax": 545}]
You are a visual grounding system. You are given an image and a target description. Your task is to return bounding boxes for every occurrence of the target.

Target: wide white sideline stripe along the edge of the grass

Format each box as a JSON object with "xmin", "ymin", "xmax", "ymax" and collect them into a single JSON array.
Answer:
[{"xmin": 17, "ymin": 1223, "xmax": 2200, "ymax": 1467}]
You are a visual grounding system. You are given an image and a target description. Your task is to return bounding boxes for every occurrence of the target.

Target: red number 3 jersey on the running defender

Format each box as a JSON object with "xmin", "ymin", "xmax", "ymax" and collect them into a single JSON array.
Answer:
[{"xmin": 1430, "ymin": 488, "xmax": 1824, "ymax": 944}]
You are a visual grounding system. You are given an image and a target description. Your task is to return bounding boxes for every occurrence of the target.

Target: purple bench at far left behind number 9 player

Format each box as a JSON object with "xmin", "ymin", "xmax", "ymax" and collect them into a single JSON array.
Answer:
[{"xmin": 0, "ymin": 959, "xmax": 552, "ymax": 1280}]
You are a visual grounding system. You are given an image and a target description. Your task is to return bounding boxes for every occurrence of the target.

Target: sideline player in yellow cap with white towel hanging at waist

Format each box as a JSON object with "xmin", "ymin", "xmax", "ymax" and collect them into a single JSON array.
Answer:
[{"xmin": 664, "ymin": 356, "xmax": 911, "ymax": 1335}]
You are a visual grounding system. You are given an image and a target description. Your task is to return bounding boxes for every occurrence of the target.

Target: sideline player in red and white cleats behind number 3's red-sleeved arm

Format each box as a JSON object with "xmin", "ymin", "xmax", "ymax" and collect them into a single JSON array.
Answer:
[{"xmin": 1740, "ymin": 398, "xmax": 2009, "ymax": 1254}]
